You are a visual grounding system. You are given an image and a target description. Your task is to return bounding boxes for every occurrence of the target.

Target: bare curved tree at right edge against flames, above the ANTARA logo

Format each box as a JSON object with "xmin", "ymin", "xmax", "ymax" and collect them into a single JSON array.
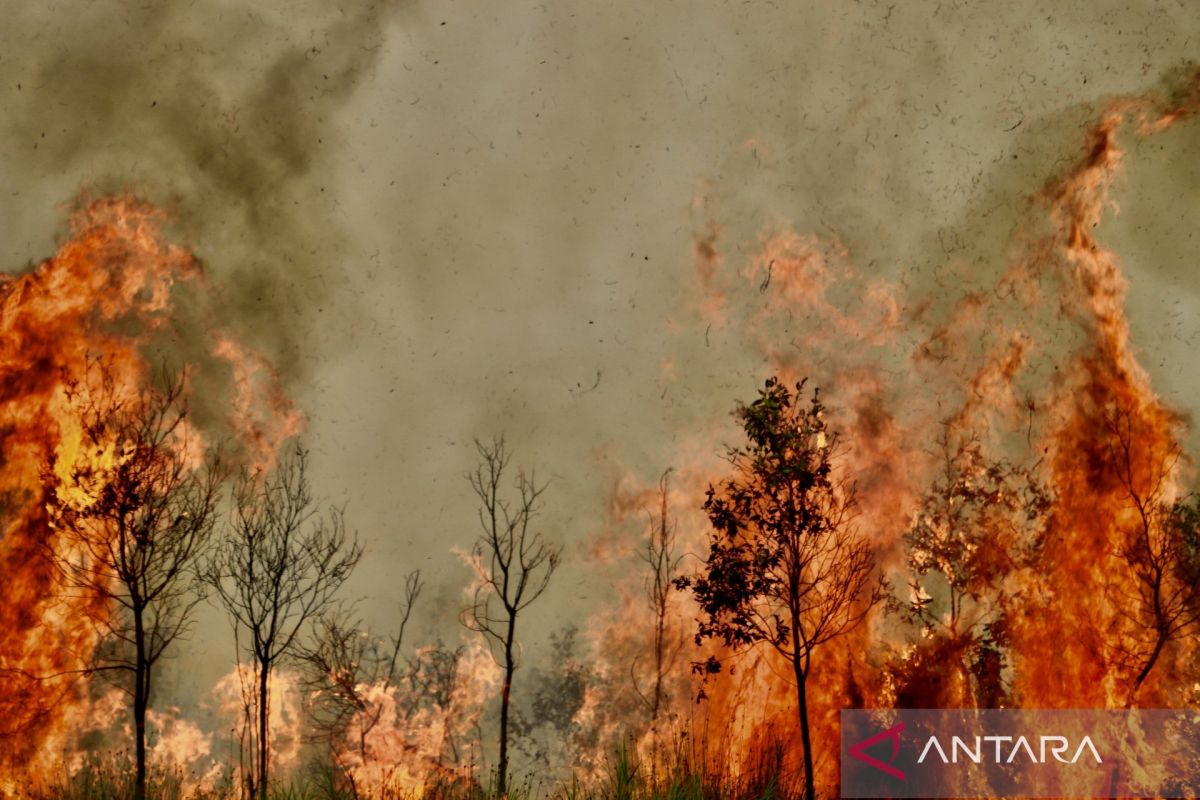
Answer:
[{"xmin": 1102, "ymin": 405, "xmax": 1200, "ymax": 708}]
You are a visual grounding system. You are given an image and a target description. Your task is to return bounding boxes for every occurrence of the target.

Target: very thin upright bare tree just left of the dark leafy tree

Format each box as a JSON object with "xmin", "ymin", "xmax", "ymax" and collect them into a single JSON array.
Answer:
[{"xmin": 630, "ymin": 469, "xmax": 684, "ymax": 738}]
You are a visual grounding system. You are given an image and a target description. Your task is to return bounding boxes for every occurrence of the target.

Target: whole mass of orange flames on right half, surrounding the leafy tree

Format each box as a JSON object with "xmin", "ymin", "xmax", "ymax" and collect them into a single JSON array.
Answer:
[{"xmin": 588, "ymin": 78, "xmax": 1200, "ymax": 786}]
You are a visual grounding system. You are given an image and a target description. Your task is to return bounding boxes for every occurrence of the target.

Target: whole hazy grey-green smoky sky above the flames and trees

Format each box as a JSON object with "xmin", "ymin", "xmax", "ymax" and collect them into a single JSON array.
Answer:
[{"xmin": 0, "ymin": 0, "xmax": 1200, "ymax": 714}]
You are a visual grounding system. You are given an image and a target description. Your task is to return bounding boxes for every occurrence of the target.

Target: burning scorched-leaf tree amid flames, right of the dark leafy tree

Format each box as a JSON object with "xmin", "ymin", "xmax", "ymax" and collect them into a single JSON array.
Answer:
[{"xmin": 898, "ymin": 423, "xmax": 1050, "ymax": 708}]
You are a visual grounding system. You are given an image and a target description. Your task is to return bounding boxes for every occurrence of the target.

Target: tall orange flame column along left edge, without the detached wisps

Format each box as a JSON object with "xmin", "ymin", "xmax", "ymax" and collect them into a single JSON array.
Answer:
[{"xmin": 0, "ymin": 199, "xmax": 198, "ymax": 768}]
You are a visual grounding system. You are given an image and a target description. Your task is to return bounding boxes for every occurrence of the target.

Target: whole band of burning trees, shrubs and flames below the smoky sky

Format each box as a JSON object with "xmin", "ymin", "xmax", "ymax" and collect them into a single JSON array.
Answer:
[{"xmin": 0, "ymin": 79, "xmax": 1200, "ymax": 800}]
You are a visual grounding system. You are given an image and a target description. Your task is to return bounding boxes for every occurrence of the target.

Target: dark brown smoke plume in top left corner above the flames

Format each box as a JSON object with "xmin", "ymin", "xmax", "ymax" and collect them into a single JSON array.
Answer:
[{"xmin": 0, "ymin": 1, "xmax": 396, "ymax": 379}]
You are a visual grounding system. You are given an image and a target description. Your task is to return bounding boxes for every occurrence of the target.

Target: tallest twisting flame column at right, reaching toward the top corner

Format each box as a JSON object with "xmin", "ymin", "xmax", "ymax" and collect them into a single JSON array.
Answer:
[{"xmin": 1014, "ymin": 89, "xmax": 1200, "ymax": 708}]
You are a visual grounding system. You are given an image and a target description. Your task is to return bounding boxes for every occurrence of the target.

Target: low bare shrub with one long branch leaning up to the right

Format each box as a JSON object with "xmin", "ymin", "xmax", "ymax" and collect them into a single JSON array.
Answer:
[{"xmin": 300, "ymin": 571, "xmax": 422, "ymax": 798}]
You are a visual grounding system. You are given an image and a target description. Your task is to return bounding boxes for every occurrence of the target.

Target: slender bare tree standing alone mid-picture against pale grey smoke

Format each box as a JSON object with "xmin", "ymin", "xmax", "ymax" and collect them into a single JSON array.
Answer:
[{"xmin": 462, "ymin": 438, "xmax": 562, "ymax": 796}]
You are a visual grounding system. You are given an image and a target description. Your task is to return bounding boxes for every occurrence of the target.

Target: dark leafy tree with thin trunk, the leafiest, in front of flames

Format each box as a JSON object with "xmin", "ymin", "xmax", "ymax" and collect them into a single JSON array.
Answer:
[{"xmin": 676, "ymin": 378, "xmax": 884, "ymax": 800}]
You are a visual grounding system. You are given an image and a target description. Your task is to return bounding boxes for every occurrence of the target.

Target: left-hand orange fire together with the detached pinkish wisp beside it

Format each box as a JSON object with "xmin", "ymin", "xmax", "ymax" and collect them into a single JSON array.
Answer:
[{"xmin": 0, "ymin": 197, "xmax": 299, "ymax": 780}]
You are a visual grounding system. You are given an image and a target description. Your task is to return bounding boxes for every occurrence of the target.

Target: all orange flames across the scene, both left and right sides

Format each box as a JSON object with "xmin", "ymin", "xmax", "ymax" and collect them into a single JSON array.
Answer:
[{"xmin": 0, "ymin": 67, "xmax": 1200, "ymax": 794}]
